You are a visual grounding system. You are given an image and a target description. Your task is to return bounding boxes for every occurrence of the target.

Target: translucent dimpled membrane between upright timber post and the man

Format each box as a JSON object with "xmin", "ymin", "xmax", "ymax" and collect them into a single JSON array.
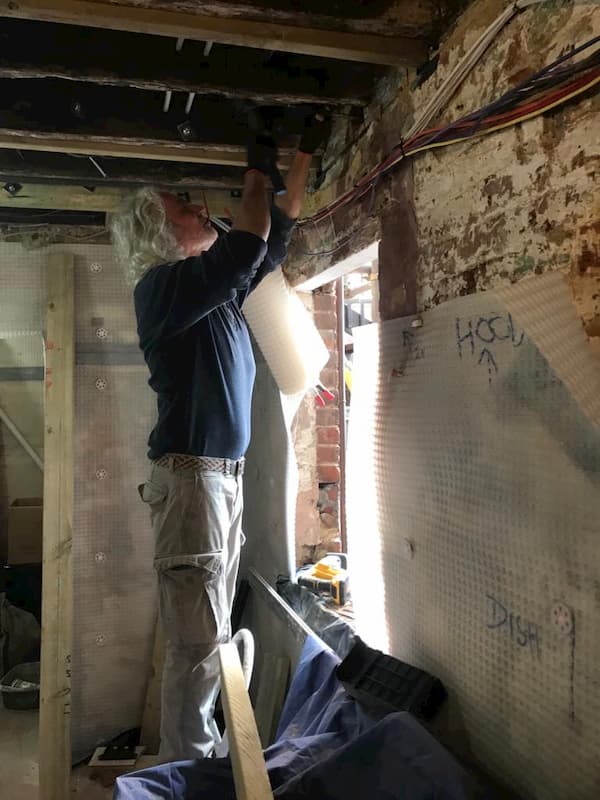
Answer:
[{"xmin": 72, "ymin": 246, "xmax": 156, "ymax": 758}]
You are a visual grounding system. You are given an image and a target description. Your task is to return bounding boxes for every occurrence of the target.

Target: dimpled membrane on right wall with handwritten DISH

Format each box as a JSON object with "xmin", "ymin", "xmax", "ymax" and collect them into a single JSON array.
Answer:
[{"xmin": 348, "ymin": 274, "xmax": 600, "ymax": 800}]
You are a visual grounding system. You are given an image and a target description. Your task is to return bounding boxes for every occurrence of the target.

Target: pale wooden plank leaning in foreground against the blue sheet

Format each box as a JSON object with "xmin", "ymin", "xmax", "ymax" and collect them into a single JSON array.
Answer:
[{"xmin": 219, "ymin": 642, "xmax": 273, "ymax": 800}]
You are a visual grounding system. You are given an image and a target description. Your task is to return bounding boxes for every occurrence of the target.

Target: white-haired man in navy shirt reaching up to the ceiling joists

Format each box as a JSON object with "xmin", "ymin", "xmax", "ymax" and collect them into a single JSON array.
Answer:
[{"xmin": 111, "ymin": 124, "xmax": 322, "ymax": 761}]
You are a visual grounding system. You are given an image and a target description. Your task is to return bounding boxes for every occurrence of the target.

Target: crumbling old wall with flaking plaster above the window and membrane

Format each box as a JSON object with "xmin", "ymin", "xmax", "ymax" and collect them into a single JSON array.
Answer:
[{"xmin": 287, "ymin": 0, "xmax": 600, "ymax": 336}]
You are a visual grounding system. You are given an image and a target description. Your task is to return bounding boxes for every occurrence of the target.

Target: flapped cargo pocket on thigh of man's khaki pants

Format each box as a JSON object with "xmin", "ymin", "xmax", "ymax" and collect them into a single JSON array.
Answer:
[{"xmin": 154, "ymin": 553, "xmax": 230, "ymax": 649}]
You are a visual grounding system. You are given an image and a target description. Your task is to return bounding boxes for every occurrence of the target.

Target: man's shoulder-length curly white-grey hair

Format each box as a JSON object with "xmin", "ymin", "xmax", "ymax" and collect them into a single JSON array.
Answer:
[{"xmin": 108, "ymin": 186, "xmax": 183, "ymax": 286}]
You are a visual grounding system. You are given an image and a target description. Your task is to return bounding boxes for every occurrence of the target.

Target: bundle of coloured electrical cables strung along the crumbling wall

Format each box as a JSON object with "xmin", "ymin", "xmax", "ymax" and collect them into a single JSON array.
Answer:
[{"xmin": 300, "ymin": 36, "xmax": 600, "ymax": 227}]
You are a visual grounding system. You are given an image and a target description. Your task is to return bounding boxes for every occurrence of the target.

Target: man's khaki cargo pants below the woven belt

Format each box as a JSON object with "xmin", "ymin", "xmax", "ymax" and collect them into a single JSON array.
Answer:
[{"xmin": 139, "ymin": 465, "xmax": 243, "ymax": 761}]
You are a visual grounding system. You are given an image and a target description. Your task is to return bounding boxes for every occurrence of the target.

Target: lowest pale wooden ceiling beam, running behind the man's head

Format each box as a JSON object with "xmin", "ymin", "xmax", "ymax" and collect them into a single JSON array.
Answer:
[{"xmin": 0, "ymin": 182, "xmax": 239, "ymax": 215}]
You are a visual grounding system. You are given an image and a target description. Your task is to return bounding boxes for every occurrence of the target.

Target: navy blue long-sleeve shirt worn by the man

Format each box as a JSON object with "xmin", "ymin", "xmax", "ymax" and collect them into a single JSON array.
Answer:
[{"xmin": 134, "ymin": 206, "xmax": 294, "ymax": 459}]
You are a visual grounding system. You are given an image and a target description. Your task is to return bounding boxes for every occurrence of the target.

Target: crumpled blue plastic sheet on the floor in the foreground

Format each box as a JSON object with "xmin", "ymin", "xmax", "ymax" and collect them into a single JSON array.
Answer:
[{"xmin": 114, "ymin": 638, "xmax": 480, "ymax": 800}]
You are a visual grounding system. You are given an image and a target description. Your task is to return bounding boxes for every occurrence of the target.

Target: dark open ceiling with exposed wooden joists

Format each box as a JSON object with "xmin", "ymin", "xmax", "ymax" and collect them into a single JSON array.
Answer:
[{"xmin": 0, "ymin": 0, "xmax": 452, "ymax": 219}]
